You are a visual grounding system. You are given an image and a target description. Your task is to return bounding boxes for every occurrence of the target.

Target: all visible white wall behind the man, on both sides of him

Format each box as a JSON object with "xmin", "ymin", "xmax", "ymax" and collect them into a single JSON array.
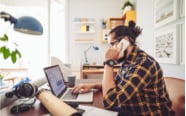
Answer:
[{"xmin": 69, "ymin": 0, "xmax": 185, "ymax": 79}]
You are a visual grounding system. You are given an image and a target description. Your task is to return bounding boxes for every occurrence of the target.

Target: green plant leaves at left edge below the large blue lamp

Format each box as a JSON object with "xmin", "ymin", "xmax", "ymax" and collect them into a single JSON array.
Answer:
[{"xmin": 0, "ymin": 34, "xmax": 21, "ymax": 63}]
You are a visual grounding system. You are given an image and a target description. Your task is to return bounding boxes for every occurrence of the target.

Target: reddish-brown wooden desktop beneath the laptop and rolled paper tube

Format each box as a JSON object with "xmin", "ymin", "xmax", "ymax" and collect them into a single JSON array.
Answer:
[{"xmin": 0, "ymin": 91, "xmax": 103, "ymax": 116}]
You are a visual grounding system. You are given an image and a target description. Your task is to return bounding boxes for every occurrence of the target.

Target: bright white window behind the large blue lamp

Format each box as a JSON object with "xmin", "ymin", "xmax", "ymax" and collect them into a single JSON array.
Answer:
[{"xmin": 0, "ymin": 0, "xmax": 48, "ymax": 78}]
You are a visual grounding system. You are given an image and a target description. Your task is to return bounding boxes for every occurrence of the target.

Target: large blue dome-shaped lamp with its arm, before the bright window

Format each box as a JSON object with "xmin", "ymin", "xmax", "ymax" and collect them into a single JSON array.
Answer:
[{"xmin": 0, "ymin": 12, "xmax": 43, "ymax": 35}]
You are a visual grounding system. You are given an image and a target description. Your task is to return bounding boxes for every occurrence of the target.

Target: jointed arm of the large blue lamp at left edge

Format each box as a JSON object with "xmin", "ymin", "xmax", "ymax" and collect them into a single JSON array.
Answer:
[{"xmin": 0, "ymin": 12, "xmax": 17, "ymax": 24}]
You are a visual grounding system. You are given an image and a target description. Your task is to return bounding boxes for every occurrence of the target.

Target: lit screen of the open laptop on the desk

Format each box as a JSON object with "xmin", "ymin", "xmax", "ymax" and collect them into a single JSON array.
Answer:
[{"xmin": 44, "ymin": 65, "xmax": 66, "ymax": 96}]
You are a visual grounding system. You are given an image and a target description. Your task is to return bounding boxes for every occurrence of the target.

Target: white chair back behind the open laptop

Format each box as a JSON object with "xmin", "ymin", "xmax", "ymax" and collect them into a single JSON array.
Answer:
[{"xmin": 51, "ymin": 56, "xmax": 72, "ymax": 81}]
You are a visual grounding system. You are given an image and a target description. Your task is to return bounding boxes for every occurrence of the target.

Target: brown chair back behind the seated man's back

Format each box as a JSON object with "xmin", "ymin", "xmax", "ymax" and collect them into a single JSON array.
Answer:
[{"xmin": 164, "ymin": 77, "xmax": 185, "ymax": 116}]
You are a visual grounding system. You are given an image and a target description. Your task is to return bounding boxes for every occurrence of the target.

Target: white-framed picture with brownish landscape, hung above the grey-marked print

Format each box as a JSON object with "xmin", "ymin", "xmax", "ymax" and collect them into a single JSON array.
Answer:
[{"xmin": 154, "ymin": 0, "xmax": 177, "ymax": 28}]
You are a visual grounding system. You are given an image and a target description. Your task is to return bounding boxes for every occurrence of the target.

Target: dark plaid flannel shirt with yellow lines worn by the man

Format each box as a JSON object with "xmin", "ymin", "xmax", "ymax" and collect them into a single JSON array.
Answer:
[{"xmin": 103, "ymin": 46, "xmax": 174, "ymax": 116}]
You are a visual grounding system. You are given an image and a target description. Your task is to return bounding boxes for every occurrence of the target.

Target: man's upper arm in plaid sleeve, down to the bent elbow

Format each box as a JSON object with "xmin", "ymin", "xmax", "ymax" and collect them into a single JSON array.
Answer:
[{"xmin": 103, "ymin": 63, "xmax": 153, "ymax": 108}]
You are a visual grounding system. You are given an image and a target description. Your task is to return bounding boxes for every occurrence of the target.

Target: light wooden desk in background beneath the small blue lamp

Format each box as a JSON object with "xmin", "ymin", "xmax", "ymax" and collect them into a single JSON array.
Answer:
[{"xmin": 81, "ymin": 65, "xmax": 120, "ymax": 79}]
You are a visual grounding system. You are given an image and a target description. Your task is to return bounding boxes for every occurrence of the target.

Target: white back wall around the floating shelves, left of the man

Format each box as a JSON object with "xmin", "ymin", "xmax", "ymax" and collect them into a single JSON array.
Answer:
[{"xmin": 69, "ymin": 0, "xmax": 123, "ymax": 71}]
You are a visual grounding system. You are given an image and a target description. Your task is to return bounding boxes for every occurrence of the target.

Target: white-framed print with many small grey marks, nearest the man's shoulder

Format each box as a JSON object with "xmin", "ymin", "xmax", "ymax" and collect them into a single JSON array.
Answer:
[{"xmin": 154, "ymin": 26, "xmax": 178, "ymax": 64}]
